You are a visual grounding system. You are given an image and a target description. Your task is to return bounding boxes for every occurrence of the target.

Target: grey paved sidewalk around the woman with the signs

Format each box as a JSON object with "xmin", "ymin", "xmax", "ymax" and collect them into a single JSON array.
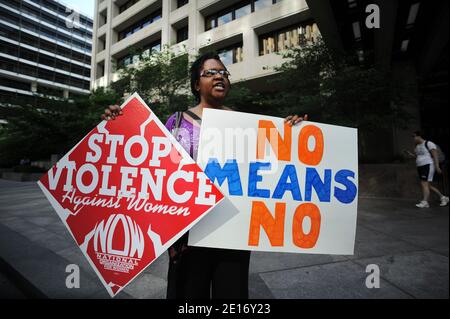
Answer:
[{"xmin": 0, "ymin": 179, "xmax": 449, "ymax": 298}]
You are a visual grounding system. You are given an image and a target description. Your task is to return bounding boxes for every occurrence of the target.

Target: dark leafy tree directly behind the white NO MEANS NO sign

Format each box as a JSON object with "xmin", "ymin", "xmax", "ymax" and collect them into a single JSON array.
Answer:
[{"xmin": 255, "ymin": 40, "xmax": 409, "ymax": 161}]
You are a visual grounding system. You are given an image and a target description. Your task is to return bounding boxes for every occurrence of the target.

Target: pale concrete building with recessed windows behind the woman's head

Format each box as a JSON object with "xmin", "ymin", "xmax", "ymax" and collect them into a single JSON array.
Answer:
[{"xmin": 91, "ymin": 0, "xmax": 319, "ymax": 88}]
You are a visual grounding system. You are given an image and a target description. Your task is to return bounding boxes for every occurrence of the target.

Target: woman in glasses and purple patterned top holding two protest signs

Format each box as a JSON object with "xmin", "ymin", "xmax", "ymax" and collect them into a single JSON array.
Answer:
[{"xmin": 102, "ymin": 53, "xmax": 307, "ymax": 299}]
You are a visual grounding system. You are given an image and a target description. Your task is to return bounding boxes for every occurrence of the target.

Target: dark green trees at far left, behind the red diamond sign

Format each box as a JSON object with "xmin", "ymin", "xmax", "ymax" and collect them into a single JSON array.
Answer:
[{"xmin": 0, "ymin": 90, "xmax": 118, "ymax": 166}]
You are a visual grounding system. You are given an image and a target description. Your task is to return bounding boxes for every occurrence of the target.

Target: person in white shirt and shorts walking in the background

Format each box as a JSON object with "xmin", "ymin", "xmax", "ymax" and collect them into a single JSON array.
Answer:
[{"xmin": 405, "ymin": 131, "xmax": 449, "ymax": 208}]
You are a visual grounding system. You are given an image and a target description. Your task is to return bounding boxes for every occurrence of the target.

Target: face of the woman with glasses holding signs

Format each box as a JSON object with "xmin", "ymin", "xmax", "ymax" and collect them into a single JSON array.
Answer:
[{"xmin": 196, "ymin": 59, "xmax": 230, "ymax": 101}]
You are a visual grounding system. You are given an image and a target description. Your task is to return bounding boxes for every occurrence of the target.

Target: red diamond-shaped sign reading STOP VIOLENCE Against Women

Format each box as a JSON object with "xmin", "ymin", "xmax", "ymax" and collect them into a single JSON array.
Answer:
[{"xmin": 38, "ymin": 93, "xmax": 223, "ymax": 297}]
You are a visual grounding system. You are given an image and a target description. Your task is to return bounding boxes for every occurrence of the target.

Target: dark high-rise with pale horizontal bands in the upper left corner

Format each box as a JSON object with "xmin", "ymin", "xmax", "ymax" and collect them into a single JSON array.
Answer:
[{"xmin": 0, "ymin": 0, "xmax": 93, "ymax": 98}]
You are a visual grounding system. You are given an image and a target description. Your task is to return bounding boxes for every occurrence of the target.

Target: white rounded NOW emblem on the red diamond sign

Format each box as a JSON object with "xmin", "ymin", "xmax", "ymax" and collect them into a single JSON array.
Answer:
[{"xmin": 94, "ymin": 214, "xmax": 145, "ymax": 258}]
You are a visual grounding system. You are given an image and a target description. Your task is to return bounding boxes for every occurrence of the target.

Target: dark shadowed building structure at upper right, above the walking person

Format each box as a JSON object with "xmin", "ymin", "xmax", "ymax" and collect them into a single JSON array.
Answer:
[{"xmin": 307, "ymin": 0, "xmax": 450, "ymax": 161}]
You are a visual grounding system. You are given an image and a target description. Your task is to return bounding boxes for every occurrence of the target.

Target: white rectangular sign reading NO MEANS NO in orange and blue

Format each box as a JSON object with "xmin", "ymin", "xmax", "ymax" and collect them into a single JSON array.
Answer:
[{"xmin": 189, "ymin": 109, "xmax": 358, "ymax": 254}]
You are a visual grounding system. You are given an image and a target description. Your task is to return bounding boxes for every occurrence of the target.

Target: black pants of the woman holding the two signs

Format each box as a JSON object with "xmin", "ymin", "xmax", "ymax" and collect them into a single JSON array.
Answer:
[{"xmin": 167, "ymin": 247, "xmax": 250, "ymax": 299}]
